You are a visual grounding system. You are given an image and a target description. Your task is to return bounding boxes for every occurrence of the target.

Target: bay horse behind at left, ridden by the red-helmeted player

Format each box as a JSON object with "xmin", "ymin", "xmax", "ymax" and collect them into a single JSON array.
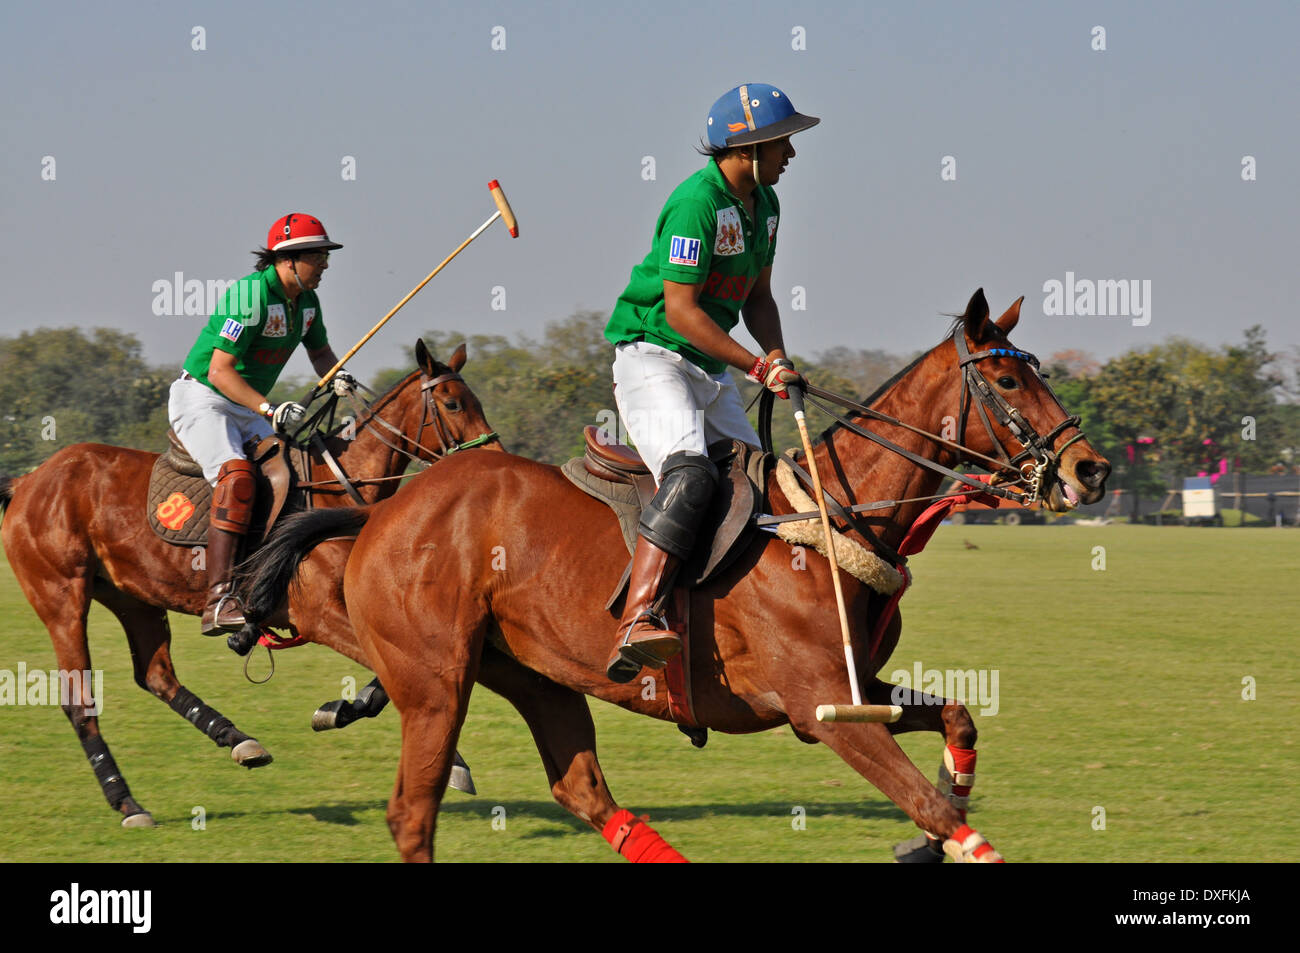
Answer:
[{"xmin": 0, "ymin": 341, "xmax": 499, "ymax": 827}]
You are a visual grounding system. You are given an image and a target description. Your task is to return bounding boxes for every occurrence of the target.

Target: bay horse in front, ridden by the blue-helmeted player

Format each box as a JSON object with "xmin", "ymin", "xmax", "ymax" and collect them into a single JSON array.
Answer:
[{"xmin": 241, "ymin": 290, "xmax": 1110, "ymax": 861}]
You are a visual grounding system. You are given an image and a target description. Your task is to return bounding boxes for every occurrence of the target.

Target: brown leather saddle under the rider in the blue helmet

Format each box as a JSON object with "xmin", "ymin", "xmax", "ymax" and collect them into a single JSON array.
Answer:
[{"xmin": 560, "ymin": 426, "xmax": 767, "ymax": 608}]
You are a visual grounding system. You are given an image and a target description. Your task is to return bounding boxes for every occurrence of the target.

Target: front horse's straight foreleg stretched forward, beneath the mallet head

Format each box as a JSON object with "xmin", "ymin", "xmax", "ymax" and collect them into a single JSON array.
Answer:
[{"xmin": 790, "ymin": 683, "xmax": 1002, "ymax": 862}]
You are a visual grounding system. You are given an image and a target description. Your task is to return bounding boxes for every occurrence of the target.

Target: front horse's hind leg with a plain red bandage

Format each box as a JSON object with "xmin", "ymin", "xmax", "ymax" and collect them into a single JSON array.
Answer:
[{"xmin": 478, "ymin": 647, "xmax": 686, "ymax": 863}]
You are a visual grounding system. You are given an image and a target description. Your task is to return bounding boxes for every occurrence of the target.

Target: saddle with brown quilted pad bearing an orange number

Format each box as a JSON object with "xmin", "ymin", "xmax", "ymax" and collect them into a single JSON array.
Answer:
[{"xmin": 146, "ymin": 428, "xmax": 297, "ymax": 551}]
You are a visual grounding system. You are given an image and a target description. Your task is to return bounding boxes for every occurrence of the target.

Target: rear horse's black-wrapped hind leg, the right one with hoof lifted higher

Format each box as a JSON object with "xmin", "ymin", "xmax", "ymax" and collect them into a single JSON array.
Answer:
[{"xmin": 95, "ymin": 582, "xmax": 272, "ymax": 768}]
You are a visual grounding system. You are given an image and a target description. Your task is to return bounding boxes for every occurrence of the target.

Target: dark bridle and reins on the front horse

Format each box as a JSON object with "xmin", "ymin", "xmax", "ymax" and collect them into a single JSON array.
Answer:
[{"xmin": 759, "ymin": 324, "xmax": 1084, "ymax": 564}]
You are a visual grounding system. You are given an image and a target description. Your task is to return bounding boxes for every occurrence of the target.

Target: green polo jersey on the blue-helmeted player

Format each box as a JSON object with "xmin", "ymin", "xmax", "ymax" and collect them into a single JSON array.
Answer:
[{"xmin": 605, "ymin": 159, "xmax": 781, "ymax": 374}]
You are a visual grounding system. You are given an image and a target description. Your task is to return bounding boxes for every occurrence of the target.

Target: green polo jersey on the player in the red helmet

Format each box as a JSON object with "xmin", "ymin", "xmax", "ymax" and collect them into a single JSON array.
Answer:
[{"xmin": 185, "ymin": 267, "xmax": 328, "ymax": 395}]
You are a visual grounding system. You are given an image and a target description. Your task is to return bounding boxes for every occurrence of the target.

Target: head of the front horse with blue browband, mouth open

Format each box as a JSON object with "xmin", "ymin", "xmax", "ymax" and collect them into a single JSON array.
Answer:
[{"xmin": 948, "ymin": 289, "xmax": 1110, "ymax": 512}]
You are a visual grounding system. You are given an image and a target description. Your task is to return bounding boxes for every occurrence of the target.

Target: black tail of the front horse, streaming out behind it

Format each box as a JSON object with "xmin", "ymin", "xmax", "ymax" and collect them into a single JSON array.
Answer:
[{"xmin": 235, "ymin": 507, "xmax": 371, "ymax": 621}]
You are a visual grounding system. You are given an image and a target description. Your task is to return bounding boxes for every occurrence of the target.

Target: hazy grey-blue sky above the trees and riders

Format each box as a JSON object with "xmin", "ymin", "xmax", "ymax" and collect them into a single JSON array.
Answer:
[{"xmin": 0, "ymin": 0, "xmax": 1300, "ymax": 374}]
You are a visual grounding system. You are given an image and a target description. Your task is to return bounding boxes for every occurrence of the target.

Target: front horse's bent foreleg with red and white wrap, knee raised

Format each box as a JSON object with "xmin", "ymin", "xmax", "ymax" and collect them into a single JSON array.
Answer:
[{"xmin": 867, "ymin": 679, "xmax": 979, "ymax": 863}]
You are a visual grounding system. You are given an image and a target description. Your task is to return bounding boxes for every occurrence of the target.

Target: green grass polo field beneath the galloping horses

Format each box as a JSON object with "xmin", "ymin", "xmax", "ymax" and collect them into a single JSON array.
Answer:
[{"xmin": 0, "ymin": 525, "xmax": 1300, "ymax": 862}]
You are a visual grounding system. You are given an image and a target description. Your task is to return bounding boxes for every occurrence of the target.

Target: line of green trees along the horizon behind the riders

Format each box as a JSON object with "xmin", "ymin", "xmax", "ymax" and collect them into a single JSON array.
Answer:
[{"xmin": 0, "ymin": 319, "xmax": 1300, "ymax": 493}]
